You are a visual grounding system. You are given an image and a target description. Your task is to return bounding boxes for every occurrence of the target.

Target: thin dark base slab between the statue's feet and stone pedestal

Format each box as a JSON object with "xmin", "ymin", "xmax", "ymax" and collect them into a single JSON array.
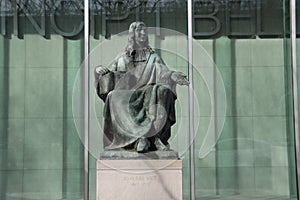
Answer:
[{"xmin": 100, "ymin": 150, "xmax": 179, "ymax": 160}]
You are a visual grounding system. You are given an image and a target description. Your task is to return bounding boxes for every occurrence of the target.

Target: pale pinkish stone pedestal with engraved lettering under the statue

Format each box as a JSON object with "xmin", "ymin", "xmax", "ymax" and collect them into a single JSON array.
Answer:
[{"xmin": 97, "ymin": 160, "xmax": 182, "ymax": 200}]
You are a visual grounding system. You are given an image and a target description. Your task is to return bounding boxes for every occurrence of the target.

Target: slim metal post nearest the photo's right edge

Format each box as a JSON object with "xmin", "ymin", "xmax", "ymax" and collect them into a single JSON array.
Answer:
[{"xmin": 290, "ymin": 0, "xmax": 300, "ymax": 198}]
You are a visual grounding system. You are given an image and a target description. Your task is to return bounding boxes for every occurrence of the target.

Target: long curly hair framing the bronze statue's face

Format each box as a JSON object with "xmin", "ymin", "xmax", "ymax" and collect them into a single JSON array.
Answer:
[{"xmin": 125, "ymin": 22, "xmax": 150, "ymax": 56}]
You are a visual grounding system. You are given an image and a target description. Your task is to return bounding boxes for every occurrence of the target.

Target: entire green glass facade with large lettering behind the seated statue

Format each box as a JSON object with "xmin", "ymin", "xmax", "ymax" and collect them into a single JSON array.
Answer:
[{"xmin": 0, "ymin": 0, "xmax": 300, "ymax": 200}]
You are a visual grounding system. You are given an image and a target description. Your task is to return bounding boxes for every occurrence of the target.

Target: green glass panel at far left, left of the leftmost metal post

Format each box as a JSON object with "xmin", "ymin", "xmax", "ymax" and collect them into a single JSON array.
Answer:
[{"xmin": 0, "ymin": 0, "xmax": 83, "ymax": 200}]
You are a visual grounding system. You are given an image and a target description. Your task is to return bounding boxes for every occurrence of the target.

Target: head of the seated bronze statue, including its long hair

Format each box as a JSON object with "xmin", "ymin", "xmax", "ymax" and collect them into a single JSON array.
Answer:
[{"xmin": 126, "ymin": 22, "xmax": 149, "ymax": 54}]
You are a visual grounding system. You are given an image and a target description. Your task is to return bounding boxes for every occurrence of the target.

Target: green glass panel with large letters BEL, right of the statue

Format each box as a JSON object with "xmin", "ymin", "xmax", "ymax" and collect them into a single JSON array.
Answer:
[{"xmin": 193, "ymin": 0, "xmax": 297, "ymax": 199}]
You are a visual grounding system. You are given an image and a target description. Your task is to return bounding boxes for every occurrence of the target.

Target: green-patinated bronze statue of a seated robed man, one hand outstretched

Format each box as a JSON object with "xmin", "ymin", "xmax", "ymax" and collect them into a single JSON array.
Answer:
[{"xmin": 95, "ymin": 22, "xmax": 189, "ymax": 152}]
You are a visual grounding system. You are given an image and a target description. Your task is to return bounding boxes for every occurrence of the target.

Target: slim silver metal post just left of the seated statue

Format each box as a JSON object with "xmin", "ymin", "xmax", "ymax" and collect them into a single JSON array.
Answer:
[{"xmin": 84, "ymin": 0, "xmax": 90, "ymax": 200}]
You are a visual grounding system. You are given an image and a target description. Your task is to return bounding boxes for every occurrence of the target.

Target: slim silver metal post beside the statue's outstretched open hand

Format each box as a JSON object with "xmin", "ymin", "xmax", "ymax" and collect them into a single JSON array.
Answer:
[{"xmin": 188, "ymin": 0, "xmax": 195, "ymax": 200}]
